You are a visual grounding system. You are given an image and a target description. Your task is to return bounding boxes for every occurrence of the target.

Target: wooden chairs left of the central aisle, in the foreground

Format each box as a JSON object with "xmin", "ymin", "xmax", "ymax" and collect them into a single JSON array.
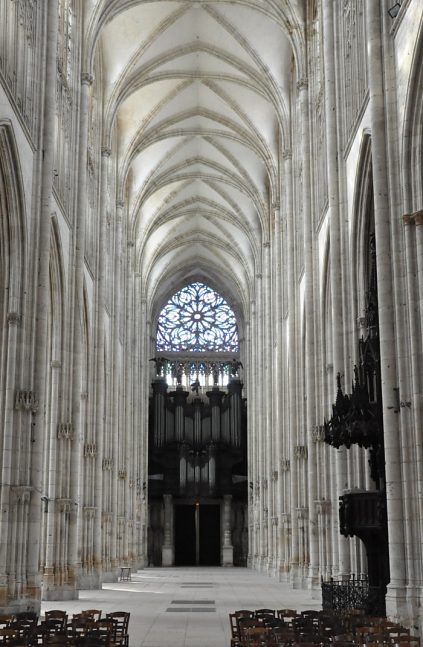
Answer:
[{"xmin": 0, "ymin": 609, "xmax": 130, "ymax": 647}]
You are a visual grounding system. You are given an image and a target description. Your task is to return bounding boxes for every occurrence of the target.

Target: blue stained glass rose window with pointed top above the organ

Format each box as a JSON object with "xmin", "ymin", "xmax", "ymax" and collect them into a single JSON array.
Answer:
[{"xmin": 156, "ymin": 283, "xmax": 239, "ymax": 352}]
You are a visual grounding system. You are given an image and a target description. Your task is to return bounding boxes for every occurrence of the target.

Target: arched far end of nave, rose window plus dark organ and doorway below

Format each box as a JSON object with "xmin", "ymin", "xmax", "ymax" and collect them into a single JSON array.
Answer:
[{"xmin": 148, "ymin": 281, "xmax": 248, "ymax": 566}]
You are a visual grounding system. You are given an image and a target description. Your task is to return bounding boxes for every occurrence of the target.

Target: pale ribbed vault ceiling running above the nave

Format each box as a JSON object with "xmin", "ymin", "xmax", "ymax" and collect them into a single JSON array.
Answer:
[{"xmin": 86, "ymin": 0, "xmax": 304, "ymax": 318}]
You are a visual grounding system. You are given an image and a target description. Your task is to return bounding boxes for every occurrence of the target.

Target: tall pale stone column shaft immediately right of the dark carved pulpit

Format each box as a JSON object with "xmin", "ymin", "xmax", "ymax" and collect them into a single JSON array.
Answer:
[{"xmin": 365, "ymin": 2, "xmax": 406, "ymax": 615}]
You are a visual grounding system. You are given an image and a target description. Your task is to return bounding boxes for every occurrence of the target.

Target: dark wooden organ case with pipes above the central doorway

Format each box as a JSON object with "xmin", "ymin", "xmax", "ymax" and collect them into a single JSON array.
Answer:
[{"xmin": 148, "ymin": 368, "xmax": 248, "ymax": 566}]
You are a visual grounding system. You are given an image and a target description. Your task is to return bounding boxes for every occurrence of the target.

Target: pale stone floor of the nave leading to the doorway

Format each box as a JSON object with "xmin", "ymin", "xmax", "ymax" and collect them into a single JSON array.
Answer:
[{"xmin": 42, "ymin": 567, "xmax": 321, "ymax": 647}]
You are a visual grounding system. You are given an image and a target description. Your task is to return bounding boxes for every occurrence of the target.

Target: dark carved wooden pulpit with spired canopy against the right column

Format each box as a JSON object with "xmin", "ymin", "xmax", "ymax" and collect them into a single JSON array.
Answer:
[{"xmin": 324, "ymin": 236, "xmax": 389, "ymax": 615}]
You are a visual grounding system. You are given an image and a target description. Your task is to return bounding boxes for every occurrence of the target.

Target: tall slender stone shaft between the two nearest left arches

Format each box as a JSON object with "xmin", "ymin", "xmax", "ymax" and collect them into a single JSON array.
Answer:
[{"xmin": 25, "ymin": 2, "xmax": 58, "ymax": 612}]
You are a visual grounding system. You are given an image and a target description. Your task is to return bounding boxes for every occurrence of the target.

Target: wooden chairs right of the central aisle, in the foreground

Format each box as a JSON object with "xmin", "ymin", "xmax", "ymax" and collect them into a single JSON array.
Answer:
[{"xmin": 229, "ymin": 609, "xmax": 420, "ymax": 647}]
